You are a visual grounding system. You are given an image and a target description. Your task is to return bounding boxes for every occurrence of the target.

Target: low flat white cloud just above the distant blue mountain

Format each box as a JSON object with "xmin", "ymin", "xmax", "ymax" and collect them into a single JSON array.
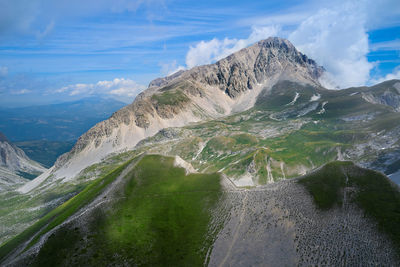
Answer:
[{"xmin": 55, "ymin": 78, "xmax": 146, "ymax": 100}]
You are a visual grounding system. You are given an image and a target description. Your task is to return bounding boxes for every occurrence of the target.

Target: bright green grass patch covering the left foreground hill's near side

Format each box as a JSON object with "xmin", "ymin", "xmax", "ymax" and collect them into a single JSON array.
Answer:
[{"xmin": 86, "ymin": 155, "xmax": 221, "ymax": 266}]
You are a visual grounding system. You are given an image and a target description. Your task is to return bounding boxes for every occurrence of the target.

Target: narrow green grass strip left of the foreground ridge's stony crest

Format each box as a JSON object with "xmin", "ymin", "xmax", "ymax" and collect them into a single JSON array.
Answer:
[{"xmin": 0, "ymin": 158, "xmax": 135, "ymax": 260}]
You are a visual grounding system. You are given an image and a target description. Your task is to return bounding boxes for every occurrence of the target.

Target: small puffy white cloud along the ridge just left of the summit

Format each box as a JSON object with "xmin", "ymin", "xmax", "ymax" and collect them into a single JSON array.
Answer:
[{"xmin": 186, "ymin": 26, "xmax": 280, "ymax": 68}]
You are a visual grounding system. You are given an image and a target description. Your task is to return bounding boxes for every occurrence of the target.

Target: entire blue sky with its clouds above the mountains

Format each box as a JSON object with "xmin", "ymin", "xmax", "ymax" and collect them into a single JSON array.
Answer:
[{"xmin": 0, "ymin": 0, "xmax": 400, "ymax": 107}]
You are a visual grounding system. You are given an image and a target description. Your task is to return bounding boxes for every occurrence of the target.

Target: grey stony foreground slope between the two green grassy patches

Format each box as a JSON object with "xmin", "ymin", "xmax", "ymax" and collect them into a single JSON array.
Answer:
[{"xmin": 209, "ymin": 179, "xmax": 400, "ymax": 266}]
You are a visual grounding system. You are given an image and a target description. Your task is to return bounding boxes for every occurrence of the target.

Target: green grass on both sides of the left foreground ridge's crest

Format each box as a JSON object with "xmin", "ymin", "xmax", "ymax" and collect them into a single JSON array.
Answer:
[{"xmin": 0, "ymin": 155, "xmax": 222, "ymax": 266}]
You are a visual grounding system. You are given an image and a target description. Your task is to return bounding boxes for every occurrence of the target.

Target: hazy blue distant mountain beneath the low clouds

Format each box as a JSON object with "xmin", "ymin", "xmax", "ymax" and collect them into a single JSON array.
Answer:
[{"xmin": 0, "ymin": 97, "xmax": 125, "ymax": 142}]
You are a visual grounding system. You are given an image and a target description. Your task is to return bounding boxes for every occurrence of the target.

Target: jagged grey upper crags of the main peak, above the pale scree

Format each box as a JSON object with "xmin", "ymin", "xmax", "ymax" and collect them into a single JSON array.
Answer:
[{"xmin": 149, "ymin": 37, "xmax": 324, "ymax": 98}]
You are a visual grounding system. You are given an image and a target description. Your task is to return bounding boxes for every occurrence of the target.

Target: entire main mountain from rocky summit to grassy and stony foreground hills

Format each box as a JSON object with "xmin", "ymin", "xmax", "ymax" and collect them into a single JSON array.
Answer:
[{"xmin": 0, "ymin": 38, "xmax": 400, "ymax": 266}]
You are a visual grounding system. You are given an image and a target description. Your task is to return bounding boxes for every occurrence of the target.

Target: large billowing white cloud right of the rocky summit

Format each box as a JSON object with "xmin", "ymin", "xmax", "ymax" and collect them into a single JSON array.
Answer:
[{"xmin": 288, "ymin": 3, "xmax": 373, "ymax": 88}]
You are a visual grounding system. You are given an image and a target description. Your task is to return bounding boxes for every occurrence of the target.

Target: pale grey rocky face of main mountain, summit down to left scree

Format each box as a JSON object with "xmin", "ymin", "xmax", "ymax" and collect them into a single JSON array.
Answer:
[{"xmin": 23, "ymin": 38, "xmax": 323, "ymax": 191}]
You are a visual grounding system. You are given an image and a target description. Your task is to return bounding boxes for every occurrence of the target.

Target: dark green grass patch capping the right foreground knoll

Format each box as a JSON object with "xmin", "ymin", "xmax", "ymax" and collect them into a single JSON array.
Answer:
[{"xmin": 299, "ymin": 162, "xmax": 400, "ymax": 251}]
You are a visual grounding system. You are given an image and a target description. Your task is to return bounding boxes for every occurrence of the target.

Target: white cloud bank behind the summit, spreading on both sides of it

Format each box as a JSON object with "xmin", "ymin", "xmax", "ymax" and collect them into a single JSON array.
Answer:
[{"xmin": 182, "ymin": 0, "xmax": 399, "ymax": 88}]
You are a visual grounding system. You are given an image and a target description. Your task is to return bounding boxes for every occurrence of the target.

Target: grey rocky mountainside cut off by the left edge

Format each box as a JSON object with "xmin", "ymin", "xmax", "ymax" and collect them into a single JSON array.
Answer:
[{"xmin": 0, "ymin": 132, "xmax": 46, "ymax": 191}]
